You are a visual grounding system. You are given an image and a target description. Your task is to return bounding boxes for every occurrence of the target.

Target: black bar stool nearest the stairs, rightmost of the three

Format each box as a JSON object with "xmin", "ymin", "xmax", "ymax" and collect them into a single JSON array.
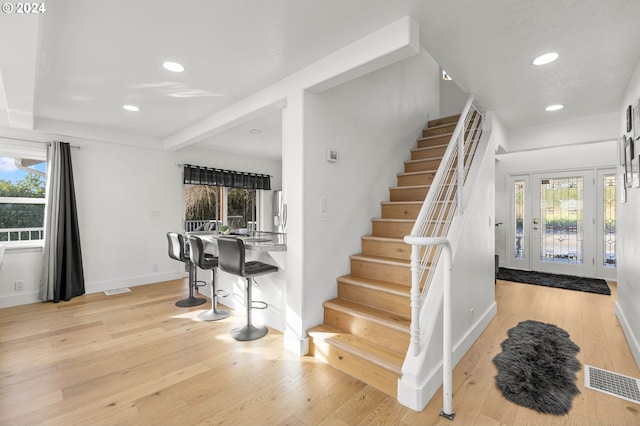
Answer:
[{"xmin": 218, "ymin": 237, "xmax": 278, "ymax": 341}]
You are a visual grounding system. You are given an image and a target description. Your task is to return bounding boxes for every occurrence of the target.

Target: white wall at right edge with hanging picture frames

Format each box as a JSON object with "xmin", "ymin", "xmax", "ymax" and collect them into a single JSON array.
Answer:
[{"xmin": 616, "ymin": 59, "xmax": 640, "ymax": 367}]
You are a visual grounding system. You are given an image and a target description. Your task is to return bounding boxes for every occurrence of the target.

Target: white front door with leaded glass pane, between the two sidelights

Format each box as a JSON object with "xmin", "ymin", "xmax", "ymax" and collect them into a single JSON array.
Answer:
[{"xmin": 530, "ymin": 171, "xmax": 595, "ymax": 276}]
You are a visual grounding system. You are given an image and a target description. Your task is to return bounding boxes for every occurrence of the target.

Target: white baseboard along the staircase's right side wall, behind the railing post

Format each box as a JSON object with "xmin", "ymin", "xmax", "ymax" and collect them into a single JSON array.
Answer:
[{"xmin": 398, "ymin": 302, "xmax": 498, "ymax": 411}]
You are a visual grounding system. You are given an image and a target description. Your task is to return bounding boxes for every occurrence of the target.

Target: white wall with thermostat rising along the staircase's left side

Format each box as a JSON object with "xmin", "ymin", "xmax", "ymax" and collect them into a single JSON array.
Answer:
[{"xmin": 302, "ymin": 47, "xmax": 439, "ymax": 329}]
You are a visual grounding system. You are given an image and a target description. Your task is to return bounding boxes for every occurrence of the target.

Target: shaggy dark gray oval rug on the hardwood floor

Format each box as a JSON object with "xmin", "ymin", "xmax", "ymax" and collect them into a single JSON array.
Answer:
[{"xmin": 493, "ymin": 320, "xmax": 581, "ymax": 415}]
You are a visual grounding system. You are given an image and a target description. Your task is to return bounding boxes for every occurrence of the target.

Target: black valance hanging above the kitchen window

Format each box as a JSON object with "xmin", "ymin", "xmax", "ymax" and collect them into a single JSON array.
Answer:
[{"xmin": 184, "ymin": 164, "xmax": 271, "ymax": 190}]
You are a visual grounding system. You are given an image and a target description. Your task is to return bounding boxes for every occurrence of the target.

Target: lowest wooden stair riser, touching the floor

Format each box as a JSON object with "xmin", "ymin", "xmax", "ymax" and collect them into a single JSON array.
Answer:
[{"xmin": 309, "ymin": 338, "xmax": 399, "ymax": 398}]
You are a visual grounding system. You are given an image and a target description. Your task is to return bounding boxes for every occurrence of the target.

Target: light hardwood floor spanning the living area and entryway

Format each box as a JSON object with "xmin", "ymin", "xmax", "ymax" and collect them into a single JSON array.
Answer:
[{"xmin": 0, "ymin": 281, "xmax": 640, "ymax": 425}]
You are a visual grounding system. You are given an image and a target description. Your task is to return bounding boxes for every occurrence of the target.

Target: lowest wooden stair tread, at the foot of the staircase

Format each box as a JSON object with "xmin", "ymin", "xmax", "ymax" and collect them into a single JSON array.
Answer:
[{"xmin": 307, "ymin": 324, "xmax": 404, "ymax": 376}]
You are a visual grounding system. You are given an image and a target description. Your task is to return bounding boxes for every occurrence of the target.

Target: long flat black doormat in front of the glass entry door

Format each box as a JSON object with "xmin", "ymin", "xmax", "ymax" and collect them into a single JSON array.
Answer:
[{"xmin": 498, "ymin": 268, "xmax": 611, "ymax": 295}]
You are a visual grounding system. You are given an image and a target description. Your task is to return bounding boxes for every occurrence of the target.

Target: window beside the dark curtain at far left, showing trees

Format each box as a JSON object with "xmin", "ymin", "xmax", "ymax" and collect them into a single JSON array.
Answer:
[{"xmin": 0, "ymin": 155, "xmax": 47, "ymax": 245}]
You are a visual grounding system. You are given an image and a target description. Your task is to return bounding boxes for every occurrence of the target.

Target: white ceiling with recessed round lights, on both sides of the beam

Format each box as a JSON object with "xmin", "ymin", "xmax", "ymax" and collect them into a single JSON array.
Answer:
[{"xmin": 0, "ymin": 0, "xmax": 640, "ymax": 157}]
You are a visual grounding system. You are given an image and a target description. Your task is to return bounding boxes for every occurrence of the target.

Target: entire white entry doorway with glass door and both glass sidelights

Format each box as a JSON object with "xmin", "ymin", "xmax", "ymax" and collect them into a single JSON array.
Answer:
[{"xmin": 507, "ymin": 169, "xmax": 616, "ymax": 279}]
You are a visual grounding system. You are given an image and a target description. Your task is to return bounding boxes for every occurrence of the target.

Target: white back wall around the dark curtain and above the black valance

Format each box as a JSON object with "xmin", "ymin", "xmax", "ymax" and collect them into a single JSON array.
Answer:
[{"xmin": 0, "ymin": 130, "xmax": 282, "ymax": 307}]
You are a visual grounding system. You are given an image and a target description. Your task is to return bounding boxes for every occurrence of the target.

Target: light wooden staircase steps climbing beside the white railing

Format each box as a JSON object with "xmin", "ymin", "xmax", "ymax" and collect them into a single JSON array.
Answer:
[{"xmin": 308, "ymin": 115, "xmax": 459, "ymax": 397}]
